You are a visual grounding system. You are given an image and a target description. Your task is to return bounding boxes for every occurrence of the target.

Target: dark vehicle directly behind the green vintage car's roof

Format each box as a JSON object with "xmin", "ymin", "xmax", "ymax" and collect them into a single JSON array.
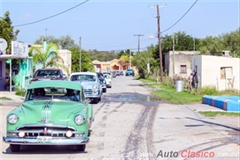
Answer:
[{"xmin": 30, "ymin": 68, "xmax": 67, "ymax": 83}]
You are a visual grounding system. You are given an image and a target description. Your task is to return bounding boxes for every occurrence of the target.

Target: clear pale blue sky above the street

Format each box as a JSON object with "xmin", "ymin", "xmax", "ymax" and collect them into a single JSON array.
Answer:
[{"xmin": 0, "ymin": 0, "xmax": 240, "ymax": 52}]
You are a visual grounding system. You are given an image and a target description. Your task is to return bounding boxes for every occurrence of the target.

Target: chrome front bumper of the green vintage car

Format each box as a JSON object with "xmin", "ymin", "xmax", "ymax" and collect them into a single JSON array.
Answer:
[{"xmin": 3, "ymin": 136, "xmax": 89, "ymax": 145}]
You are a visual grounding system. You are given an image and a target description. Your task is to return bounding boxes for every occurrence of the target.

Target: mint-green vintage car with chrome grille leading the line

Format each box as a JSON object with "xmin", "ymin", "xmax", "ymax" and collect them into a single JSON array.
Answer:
[{"xmin": 3, "ymin": 80, "xmax": 93, "ymax": 152}]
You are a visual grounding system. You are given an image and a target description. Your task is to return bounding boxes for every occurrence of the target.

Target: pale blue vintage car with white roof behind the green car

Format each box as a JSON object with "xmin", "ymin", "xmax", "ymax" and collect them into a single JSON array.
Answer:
[{"xmin": 68, "ymin": 72, "xmax": 102, "ymax": 103}]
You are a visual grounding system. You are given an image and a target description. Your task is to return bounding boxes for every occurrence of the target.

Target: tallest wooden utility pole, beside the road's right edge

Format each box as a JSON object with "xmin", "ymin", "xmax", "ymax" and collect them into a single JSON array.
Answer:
[{"xmin": 157, "ymin": 5, "xmax": 163, "ymax": 82}]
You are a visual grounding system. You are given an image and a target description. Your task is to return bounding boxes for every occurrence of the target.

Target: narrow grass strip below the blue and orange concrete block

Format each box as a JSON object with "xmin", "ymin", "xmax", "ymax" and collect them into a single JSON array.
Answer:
[{"xmin": 198, "ymin": 111, "xmax": 240, "ymax": 117}]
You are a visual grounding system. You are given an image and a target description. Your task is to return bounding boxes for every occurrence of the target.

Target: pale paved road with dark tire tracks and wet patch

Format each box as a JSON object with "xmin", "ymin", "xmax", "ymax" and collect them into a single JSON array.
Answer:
[{"xmin": 0, "ymin": 76, "xmax": 240, "ymax": 160}]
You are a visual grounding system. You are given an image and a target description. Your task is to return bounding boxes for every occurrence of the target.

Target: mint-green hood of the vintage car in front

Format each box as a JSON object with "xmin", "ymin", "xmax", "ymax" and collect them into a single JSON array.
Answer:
[{"xmin": 22, "ymin": 100, "xmax": 86, "ymax": 125}]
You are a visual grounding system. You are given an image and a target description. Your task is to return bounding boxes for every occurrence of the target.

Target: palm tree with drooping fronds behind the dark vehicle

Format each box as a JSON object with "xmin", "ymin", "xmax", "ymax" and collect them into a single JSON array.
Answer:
[{"xmin": 29, "ymin": 43, "xmax": 69, "ymax": 75}]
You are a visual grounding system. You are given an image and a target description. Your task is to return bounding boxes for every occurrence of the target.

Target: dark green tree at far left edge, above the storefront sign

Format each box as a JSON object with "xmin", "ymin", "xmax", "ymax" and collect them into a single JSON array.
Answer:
[{"xmin": 0, "ymin": 12, "xmax": 20, "ymax": 54}]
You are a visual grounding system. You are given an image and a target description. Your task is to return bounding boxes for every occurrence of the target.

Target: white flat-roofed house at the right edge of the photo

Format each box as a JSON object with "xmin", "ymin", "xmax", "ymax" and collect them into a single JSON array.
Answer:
[{"xmin": 192, "ymin": 55, "xmax": 240, "ymax": 91}]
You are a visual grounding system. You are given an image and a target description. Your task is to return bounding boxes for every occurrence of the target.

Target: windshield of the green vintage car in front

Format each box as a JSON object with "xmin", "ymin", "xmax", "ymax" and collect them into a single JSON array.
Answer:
[{"xmin": 25, "ymin": 87, "xmax": 84, "ymax": 102}]
